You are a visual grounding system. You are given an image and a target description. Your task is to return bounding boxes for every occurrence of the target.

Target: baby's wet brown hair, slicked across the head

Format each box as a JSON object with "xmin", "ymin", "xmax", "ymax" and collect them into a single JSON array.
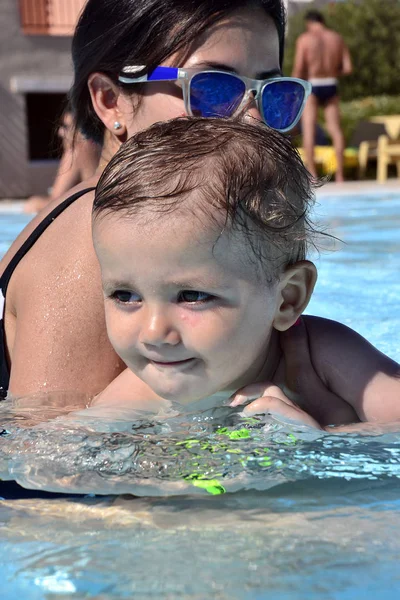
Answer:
[{"xmin": 93, "ymin": 117, "xmax": 316, "ymax": 279}]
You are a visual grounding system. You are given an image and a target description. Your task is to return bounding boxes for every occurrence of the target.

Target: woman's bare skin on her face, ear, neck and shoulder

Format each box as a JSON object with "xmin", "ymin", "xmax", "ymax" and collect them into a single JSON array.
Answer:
[{"xmin": 2, "ymin": 7, "xmax": 288, "ymax": 404}]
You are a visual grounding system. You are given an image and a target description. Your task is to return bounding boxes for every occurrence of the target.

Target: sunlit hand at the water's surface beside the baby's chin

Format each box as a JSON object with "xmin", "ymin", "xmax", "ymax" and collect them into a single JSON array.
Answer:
[{"xmin": 230, "ymin": 382, "xmax": 321, "ymax": 429}]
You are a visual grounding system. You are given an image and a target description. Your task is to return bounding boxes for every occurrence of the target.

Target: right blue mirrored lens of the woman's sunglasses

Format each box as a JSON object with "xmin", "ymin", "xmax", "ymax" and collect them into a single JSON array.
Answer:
[{"xmin": 261, "ymin": 81, "xmax": 305, "ymax": 130}]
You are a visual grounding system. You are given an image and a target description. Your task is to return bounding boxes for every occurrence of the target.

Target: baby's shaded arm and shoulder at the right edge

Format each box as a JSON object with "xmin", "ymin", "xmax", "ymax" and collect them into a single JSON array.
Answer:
[{"xmin": 283, "ymin": 316, "xmax": 400, "ymax": 424}]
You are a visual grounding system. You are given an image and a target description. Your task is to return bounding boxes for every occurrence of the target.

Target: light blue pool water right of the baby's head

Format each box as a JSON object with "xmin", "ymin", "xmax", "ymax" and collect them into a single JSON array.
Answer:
[{"xmin": 307, "ymin": 191, "xmax": 400, "ymax": 361}]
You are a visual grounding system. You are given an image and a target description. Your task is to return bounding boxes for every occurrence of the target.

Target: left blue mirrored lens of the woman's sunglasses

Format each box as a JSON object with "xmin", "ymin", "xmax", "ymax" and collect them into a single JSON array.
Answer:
[{"xmin": 190, "ymin": 73, "xmax": 246, "ymax": 117}]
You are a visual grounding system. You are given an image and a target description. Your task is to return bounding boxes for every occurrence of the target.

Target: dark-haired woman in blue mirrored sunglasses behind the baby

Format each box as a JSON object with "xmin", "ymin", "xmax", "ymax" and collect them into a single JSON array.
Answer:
[{"xmin": 0, "ymin": 0, "xmax": 308, "ymax": 404}]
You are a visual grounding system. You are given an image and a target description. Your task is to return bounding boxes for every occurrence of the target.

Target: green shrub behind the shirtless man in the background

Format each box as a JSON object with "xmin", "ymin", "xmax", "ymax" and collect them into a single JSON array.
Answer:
[{"xmin": 284, "ymin": 0, "xmax": 400, "ymax": 101}]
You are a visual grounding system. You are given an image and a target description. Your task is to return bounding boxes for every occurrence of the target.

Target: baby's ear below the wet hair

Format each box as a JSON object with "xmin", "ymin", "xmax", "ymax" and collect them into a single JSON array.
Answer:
[{"xmin": 273, "ymin": 260, "xmax": 317, "ymax": 331}]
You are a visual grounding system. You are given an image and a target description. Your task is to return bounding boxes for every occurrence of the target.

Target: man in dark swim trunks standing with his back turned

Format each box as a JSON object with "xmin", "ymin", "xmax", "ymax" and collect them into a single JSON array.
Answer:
[{"xmin": 293, "ymin": 10, "xmax": 352, "ymax": 182}]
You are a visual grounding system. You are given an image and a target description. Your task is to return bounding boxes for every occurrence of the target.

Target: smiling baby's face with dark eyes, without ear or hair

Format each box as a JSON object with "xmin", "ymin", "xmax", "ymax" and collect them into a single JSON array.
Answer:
[{"xmin": 93, "ymin": 211, "xmax": 278, "ymax": 404}]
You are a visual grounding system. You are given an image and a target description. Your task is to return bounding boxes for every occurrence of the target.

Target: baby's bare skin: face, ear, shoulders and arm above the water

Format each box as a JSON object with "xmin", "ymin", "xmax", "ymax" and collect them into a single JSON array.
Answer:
[{"xmin": 93, "ymin": 192, "xmax": 400, "ymax": 431}]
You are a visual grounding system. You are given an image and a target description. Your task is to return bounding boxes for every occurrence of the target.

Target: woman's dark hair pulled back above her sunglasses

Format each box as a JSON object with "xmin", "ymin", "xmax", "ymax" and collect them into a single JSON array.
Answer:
[{"xmin": 69, "ymin": 0, "xmax": 285, "ymax": 144}]
